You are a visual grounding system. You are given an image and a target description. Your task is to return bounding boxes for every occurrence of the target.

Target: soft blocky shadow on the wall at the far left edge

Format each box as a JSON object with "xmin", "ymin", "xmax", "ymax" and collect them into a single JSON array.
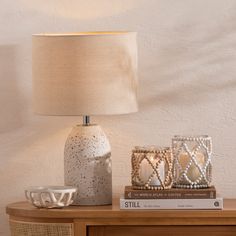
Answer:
[{"xmin": 0, "ymin": 45, "xmax": 24, "ymax": 133}]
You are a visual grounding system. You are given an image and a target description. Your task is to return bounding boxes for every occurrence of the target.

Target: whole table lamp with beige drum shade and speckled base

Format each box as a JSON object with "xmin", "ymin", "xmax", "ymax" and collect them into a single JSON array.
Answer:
[{"xmin": 32, "ymin": 32, "xmax": 137, "ymax": 205}]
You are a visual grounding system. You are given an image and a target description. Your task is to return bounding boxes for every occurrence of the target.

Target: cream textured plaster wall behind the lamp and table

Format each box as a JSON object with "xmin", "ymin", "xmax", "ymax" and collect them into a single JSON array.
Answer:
[{"xmin": 0, "ymin": 0, "xmax": 236, "ymax": 236}]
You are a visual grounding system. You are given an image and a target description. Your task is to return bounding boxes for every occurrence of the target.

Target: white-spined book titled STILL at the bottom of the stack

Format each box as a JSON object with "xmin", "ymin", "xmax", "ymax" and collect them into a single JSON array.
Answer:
[{"xmin": 120, "ymin": 196, "xmax": 223, "ymax": 210}]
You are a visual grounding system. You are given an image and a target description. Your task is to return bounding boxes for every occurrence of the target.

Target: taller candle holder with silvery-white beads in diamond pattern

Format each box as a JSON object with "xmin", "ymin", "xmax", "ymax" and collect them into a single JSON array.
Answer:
[{"xmin": 172, "ymin": 135, "xmax": 212, "ymax": 188}]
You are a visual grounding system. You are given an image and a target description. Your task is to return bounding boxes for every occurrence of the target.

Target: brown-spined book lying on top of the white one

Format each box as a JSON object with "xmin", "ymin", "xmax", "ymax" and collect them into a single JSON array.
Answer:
[{"xmin": 124, "ymin": 186, "xmax": 216, "ymax": 199}]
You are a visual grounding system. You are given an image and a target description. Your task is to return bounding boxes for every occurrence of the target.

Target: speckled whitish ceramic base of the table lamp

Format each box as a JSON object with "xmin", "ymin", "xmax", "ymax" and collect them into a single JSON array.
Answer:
[{"xmin": 64, "ymin": 125, "xmax": 112, "ymax": 205}]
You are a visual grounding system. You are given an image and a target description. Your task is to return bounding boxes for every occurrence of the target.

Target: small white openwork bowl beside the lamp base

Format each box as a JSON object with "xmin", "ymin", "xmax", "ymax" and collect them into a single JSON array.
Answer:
[{"xmin": 25, "ymin": 186, "xmax": 77, "ymax": 208}]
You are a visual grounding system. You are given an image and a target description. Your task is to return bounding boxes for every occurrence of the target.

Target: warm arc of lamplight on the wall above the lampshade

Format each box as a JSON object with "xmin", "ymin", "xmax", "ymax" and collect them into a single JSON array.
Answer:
[{"xmin": 20, "ymin": 0, "xmax": 145, "ymax": 20}]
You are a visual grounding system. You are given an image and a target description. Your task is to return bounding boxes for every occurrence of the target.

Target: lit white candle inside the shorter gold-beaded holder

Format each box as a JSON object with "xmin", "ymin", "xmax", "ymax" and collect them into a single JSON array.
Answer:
[{"xmin": 139, "ymin": 157, "xmax": 165, "ymax": 186}]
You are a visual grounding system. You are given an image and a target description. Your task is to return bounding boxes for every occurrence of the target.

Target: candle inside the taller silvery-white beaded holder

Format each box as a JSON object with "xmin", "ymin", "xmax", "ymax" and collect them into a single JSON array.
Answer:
[{"xmin": 179, "ymin": 152, "xmax": 205, "ymax": 184}]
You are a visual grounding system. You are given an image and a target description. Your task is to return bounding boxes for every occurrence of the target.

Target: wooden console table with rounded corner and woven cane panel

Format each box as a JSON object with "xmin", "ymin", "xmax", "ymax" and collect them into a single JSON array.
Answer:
[{"xmin": 6, "ymin": 199, "xmax": 236, "ymax": 236}]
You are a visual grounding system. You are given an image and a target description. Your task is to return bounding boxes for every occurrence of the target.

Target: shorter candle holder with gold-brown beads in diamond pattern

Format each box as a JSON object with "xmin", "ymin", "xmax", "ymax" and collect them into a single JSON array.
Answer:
[{"xmin": 131, "ymin": 147, "xmax": 173, "ymax": 189}]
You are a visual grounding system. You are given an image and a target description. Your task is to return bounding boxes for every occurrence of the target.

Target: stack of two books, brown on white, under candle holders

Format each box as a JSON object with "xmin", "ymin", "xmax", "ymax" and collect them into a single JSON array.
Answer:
[{"xmin": 120, "ymin": 186, "xmax": 223, "ymax": 210}]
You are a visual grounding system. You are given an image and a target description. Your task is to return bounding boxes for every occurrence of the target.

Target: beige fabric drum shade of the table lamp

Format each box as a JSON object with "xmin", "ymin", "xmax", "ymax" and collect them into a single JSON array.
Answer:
[{"xmin": 33, "ymin": 32, "xmax": 137, "ymax": 115}]
